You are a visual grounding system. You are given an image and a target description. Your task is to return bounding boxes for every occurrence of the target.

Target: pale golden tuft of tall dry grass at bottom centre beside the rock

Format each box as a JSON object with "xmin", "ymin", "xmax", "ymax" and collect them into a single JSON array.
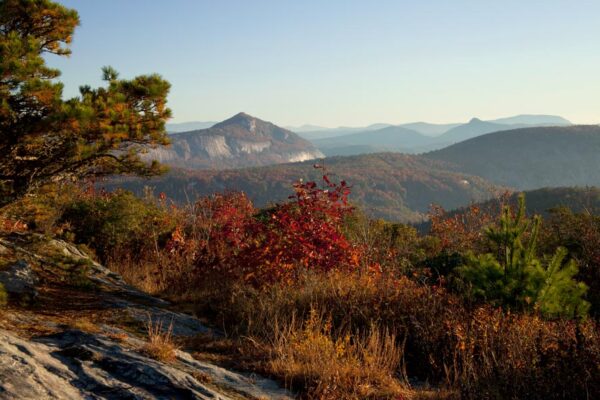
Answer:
[{"xmin": 268, "ymin": 309, "xmax": 408, "ymax": 399}]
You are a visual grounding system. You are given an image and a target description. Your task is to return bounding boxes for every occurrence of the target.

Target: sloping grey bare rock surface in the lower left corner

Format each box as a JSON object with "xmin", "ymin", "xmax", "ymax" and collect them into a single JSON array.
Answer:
[{"xmin": 0, "ymin": 234, "xmax": 294, "ymax": 400}]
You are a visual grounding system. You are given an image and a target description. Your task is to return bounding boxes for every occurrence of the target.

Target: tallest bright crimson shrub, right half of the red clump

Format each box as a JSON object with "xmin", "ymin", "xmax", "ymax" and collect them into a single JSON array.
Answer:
[{"xmin": 245, "ymin": 175, "xmax": 359, "ymax": 282}]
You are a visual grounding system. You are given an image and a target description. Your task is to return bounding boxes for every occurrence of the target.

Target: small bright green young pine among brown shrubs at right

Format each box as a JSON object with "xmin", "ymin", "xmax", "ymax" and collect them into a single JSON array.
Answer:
[{"xmin": 457, "ymin": 195, "xmax": 589, "ymax": 317}]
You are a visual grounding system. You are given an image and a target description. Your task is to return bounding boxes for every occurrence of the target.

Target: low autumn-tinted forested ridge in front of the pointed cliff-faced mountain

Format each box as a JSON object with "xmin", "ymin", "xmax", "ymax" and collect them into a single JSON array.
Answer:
[{"xmin": 109, "ymin": 153, "xmax": 503, "ymax": 222}]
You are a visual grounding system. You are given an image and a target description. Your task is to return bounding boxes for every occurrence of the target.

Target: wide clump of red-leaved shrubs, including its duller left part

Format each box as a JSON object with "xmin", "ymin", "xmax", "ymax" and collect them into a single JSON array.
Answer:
[{"xmin": 167, "ymin": 169, "xmax": 360, "ymax": 287}]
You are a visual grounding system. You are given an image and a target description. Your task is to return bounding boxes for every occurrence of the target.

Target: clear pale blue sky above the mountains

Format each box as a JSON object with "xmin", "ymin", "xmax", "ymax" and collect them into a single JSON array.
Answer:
[{"xmin": 49, "ymin": 0, "xmax": 600, "ymax": 126}]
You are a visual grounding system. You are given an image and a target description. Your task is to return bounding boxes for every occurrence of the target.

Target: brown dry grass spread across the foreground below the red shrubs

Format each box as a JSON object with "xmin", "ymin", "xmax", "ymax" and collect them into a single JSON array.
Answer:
[{"xmin": 105, "ymin": 236, "xmax": 600, "ymax": 399}]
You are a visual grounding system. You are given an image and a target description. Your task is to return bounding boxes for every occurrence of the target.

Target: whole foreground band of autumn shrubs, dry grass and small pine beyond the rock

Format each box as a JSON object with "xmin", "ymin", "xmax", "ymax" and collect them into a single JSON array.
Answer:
[{"xmin": 4, "ymin": 174, "xmax": 600, "ymax": 399}]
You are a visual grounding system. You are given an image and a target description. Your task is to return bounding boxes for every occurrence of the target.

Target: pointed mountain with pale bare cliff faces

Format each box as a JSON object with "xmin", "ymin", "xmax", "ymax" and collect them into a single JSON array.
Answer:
[{"xmin": 145, "ymin": 113, "xmax": 324, "ymax": 169}]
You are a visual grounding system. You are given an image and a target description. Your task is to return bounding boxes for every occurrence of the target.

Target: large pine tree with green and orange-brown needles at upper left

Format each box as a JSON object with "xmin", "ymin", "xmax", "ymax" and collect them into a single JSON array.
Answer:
[{"xmin": 0, "ymin": 0, "xmax": 170, "ymax": 206}]
